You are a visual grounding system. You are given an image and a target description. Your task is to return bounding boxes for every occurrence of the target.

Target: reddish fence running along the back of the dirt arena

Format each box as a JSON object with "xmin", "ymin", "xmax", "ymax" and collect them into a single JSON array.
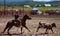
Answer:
[{"xmin": 0, "ymin": 10, "xmax": 60, "ymax": 15}]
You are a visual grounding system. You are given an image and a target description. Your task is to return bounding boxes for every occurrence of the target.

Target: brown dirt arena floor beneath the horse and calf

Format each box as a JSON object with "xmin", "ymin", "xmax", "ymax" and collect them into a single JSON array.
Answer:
[{"xmin": 0, "ymin": 16, "xmax": 60, "ymax": 36}]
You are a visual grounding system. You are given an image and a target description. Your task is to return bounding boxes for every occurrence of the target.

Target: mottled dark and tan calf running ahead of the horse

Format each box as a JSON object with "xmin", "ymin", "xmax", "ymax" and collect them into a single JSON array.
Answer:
[{"xmin": 36, "ymin": 22, "xmax": 56, "ymax": 33}]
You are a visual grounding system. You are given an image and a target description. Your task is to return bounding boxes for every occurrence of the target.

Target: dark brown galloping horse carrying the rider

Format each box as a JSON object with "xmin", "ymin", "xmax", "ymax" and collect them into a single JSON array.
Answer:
[{"xmin": 2, "ymin": 15, "xmax": 31, "ymax": 34}]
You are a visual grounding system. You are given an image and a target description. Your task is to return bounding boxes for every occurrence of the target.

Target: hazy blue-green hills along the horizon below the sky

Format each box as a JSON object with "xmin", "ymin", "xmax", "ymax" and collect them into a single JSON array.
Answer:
[{"xmin": 0, "ymin": 1, "xmax": 60, "ymax": 6}]
